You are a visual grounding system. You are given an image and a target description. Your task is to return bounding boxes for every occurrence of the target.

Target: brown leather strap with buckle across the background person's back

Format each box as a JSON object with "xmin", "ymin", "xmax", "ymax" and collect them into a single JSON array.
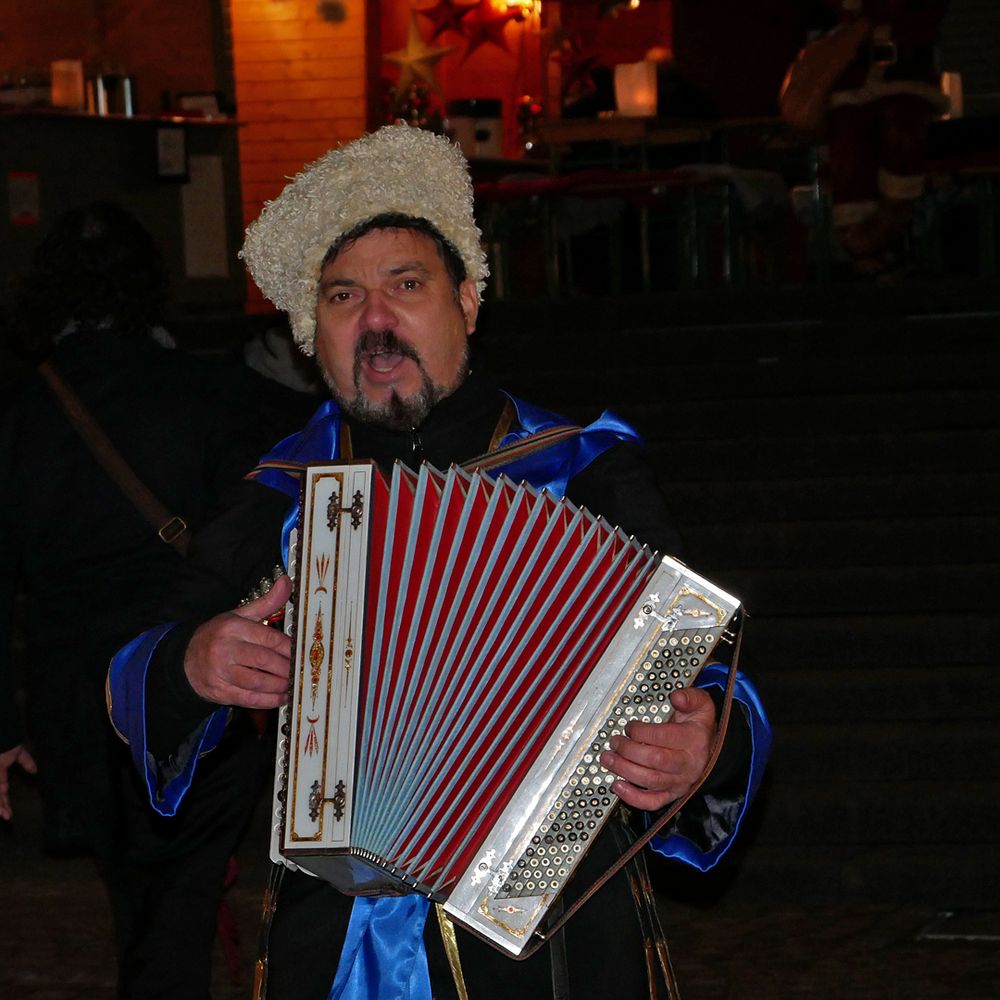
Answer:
[{"xmin": 38, "ymin": 361, "xmax": 191, "ymax": 556}]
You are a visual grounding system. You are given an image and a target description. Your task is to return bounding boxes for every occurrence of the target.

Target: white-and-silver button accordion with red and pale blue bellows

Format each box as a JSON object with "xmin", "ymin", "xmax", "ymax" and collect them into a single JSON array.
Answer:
[{"xmin": 271, "ymin": 463, "xmax": 739, "ymax": 956}]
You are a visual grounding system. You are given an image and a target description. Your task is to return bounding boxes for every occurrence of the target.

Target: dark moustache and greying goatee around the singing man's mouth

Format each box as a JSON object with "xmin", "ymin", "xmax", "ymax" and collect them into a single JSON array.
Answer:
[{"xmin": 323, "ymin": 330, "xmax": 469, "ymax": 431}]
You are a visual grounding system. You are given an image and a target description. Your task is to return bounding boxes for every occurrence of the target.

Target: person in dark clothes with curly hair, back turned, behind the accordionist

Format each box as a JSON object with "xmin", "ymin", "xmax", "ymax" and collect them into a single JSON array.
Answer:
[{"xmin": 0, "ymin": 203, "xmax": 311, "ymax": 1000}]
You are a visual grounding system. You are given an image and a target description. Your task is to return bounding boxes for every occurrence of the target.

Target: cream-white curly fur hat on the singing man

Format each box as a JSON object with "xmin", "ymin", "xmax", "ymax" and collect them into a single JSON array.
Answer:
[{"xmin": 240, "ymin": 125, "xmax": 489, "ymax": 354}]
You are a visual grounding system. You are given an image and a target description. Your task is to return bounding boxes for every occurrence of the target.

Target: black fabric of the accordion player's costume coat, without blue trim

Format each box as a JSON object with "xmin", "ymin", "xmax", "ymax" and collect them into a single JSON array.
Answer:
[{"xmin": 146, "ymin": 378, "xmax": 752, "ymax": 1000}]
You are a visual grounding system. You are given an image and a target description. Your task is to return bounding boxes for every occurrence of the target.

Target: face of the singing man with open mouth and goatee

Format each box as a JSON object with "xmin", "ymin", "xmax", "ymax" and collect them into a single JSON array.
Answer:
[{"xmin": 316, "ymin": 229, "xmax": 479, "ymax": 429}]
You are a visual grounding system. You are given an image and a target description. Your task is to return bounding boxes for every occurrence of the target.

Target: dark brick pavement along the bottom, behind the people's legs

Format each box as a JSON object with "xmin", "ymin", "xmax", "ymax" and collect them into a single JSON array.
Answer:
[{"xmin": 0, "ymin": 782, "xmax": 1000, "ymax": 1000}]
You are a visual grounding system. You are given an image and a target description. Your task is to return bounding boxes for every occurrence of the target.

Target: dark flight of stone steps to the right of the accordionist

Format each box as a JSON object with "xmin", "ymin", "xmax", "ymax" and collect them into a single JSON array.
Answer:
[{"xmin": 483, "ymin": 287, "xmax": 1000, "ymax": 907}]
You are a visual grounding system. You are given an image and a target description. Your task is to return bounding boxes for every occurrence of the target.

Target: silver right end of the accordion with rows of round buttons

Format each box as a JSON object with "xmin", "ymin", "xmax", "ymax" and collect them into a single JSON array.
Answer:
[{"xmin": 445, "ymin": 561, "xmax": 739, "ymax": 955}]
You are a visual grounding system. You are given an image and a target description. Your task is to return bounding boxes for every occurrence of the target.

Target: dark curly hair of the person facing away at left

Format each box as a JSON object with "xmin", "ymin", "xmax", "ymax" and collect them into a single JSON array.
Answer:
[{"xmin": 14, "ymin": 201, "xmax": 167, "ymax": 353}]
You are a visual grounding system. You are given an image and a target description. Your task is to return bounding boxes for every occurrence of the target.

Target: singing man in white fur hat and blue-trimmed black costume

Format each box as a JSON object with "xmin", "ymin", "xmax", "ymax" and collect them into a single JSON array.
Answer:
[{"xmin": 103, "ymin": 126, "xmax": 770, "ymax": 1000}]
